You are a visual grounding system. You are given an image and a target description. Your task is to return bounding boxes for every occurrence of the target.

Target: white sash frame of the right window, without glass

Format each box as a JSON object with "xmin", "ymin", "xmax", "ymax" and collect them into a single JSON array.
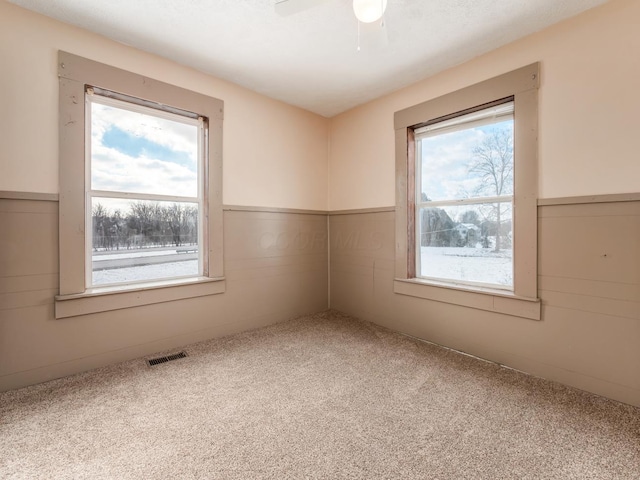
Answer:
[{"xmin": 414, "ymin": 98, "xmax": 515, "ymax": 291}]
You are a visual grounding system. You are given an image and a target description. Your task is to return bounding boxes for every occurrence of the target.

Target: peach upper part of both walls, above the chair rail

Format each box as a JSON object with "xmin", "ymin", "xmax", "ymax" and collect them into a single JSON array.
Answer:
[{"xmin": 0, "ymin": 0, "xmax": 640, "ymax": 210}]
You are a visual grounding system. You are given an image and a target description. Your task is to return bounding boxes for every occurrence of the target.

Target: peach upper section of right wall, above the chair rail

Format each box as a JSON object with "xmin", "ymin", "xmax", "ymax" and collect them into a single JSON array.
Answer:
[{"xmin": 329, "ymin": 0, "xmax": 640, "ymax": 210}]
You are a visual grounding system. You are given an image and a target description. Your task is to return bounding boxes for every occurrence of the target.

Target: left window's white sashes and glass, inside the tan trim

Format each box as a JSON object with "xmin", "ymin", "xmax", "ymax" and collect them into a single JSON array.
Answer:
[{"xmin": 85, "ymin": 88, "xmax": 207, "ymax": 287}]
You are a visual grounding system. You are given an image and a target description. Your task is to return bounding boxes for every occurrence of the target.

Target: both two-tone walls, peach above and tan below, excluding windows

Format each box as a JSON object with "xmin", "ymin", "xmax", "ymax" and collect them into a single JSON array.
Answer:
[{"xmin": 0, "ymin": 0, "xmax": 640, "ymax": 405}]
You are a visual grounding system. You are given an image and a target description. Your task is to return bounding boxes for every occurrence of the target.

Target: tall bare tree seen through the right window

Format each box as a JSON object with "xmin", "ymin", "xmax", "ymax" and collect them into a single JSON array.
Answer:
[{"xmin": 469, "ymin": 128, "xmax": 513, "ymax": 252}]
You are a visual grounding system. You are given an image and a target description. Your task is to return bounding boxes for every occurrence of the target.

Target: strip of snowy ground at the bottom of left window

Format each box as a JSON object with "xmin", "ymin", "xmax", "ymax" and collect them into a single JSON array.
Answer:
[{"xmin": 93, "ymin": 260, "xmax": 198, "ymax": 285}]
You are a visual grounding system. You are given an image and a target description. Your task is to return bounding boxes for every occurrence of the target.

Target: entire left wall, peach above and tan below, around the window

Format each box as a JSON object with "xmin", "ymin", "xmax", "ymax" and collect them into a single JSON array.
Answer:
[{"xmin": 0, "ymin": 2, "xmax": 328, "ymax": 390}]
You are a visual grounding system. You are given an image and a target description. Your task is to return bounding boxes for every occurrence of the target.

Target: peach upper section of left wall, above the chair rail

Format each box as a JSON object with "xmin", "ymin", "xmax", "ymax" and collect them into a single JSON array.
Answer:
[{"xmin": 0, "ymin": 2, "xmax": 329, "ymax": 210}]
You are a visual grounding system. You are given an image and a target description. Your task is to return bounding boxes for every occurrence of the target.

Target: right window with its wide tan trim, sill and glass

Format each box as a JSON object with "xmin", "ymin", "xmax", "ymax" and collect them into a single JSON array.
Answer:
[{"xmin": 394, "ymin": 64, "xmax": 540, "ymax": 319}]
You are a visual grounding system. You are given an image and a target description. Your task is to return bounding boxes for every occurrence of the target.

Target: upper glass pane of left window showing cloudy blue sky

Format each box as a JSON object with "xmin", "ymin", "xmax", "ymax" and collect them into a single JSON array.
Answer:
[{"xmin": 91, "ymin": 101, "xmax": 199, "ymax": 197}]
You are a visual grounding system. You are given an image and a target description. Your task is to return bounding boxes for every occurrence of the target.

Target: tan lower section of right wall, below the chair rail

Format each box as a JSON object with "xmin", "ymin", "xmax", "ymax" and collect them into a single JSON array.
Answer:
[{"xmin": 329, "ymin": 201, "xmax": 640, "ymax": 406}]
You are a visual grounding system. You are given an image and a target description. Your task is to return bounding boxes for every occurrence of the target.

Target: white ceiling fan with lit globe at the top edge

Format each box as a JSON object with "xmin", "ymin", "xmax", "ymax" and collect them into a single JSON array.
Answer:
[{"xmin": 275, "ymin": 0, "xmax": 389, "ymax": 51}]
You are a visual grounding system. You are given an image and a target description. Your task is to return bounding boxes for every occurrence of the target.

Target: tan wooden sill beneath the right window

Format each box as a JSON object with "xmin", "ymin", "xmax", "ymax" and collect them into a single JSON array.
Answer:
[{"xmin": 393, "ymin": 278, "xmax": 541, "ymax": 320}]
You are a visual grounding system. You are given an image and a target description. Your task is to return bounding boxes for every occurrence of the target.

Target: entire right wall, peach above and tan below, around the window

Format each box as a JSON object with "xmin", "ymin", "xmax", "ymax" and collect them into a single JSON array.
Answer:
[{"xmin": 329, "ymin": 0, "xmax": 640, "ymax": 406}]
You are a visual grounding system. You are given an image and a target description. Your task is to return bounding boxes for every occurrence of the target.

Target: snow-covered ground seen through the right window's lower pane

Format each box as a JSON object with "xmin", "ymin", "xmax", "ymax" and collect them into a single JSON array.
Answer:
[{"xmin": 419, "ymin": 247, "xmax": 513, "ymax": 285}]
